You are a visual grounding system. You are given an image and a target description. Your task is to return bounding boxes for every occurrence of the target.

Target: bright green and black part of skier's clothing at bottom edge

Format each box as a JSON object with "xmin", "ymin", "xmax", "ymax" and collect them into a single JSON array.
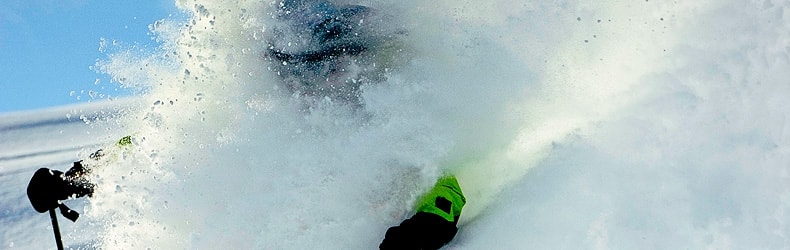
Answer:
[{"xmin": 379, "ymin": 176, "xmax": 466, "ymax": 250}]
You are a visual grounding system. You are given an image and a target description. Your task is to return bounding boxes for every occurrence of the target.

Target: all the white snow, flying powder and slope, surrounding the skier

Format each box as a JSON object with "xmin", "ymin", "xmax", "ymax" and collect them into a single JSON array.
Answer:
[{"xmin": 0, "ymin": 0, "xmax": 790, "ymax": 249}]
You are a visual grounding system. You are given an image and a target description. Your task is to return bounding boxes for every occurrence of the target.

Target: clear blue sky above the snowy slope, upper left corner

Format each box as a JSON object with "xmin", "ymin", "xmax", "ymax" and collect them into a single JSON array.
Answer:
[{"xmin": 0, "ymin": 0, "xmax": 179, "ymax": 113}]
